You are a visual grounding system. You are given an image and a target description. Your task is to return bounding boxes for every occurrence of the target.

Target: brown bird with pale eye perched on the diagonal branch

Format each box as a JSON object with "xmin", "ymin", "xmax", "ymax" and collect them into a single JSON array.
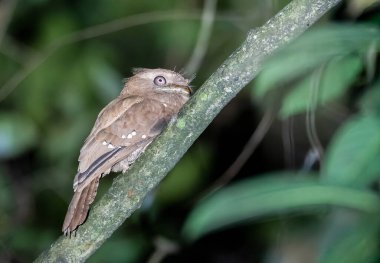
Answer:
[{"xmin": 62, "ymin": 68, "xmax": 191, "ymax": 235}]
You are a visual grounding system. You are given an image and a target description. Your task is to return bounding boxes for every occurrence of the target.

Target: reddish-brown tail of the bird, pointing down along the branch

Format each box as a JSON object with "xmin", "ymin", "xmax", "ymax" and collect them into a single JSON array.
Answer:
[{"xmin": 62, "ymin": 176, "xmax": 100, "ymax": 235}]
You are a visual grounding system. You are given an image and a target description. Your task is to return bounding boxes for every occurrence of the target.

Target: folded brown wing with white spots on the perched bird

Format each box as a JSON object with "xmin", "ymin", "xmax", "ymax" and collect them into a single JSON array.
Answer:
[{"xmin": 74, "ymin": 97, "xmax": 170, "ymax": 191}]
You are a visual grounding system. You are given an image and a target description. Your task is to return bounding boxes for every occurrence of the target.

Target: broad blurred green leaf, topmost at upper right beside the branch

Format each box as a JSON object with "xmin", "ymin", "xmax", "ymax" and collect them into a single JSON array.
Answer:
[{"xmin": 253, "ymin": 24, "xmax": 380, "ymax": 97}]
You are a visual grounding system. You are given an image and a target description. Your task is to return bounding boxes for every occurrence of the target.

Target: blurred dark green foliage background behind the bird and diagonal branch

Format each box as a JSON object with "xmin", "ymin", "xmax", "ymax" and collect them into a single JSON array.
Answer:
[{"xmin": 0, "ymin": 0, "xmax": 380, "ymax": 263}]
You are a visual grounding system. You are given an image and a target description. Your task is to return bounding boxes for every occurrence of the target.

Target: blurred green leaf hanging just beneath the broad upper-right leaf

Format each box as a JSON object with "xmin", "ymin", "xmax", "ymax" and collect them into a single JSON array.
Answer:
[{"xmin": 280, "ymin": 56, "xmax": 363, "ymax": 118}]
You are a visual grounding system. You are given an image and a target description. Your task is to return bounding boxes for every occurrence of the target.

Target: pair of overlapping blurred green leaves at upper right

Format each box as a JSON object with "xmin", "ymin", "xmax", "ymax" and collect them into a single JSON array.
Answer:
[{"xmin": 252, "ymin": 25, "xmax": 380, "ymax": 118}]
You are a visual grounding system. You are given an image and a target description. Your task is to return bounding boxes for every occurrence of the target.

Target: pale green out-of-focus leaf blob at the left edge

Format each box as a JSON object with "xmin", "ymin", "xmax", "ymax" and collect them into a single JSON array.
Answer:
[{"xmin": 0, "ymin": 113, "xmax": 37, "ymax": 158}]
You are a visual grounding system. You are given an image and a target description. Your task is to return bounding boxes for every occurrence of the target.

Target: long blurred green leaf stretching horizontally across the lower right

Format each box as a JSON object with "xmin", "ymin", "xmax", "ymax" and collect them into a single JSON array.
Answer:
[{"xmin": 183, "ymin": 173, "xmax": 379, "ymax": 240}]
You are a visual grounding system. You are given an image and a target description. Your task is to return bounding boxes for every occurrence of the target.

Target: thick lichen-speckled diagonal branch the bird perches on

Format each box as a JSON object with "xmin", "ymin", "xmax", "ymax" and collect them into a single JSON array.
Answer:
[{"xmin": 36, "ymin": 0, "xmax": 340, "ymax": 262}]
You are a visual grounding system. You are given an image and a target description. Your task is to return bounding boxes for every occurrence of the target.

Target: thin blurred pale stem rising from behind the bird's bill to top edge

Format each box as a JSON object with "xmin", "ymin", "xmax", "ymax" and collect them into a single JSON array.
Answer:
[{"xmin": 184, "ymin": 0, "xmax": 218, "ymax": 76}]
